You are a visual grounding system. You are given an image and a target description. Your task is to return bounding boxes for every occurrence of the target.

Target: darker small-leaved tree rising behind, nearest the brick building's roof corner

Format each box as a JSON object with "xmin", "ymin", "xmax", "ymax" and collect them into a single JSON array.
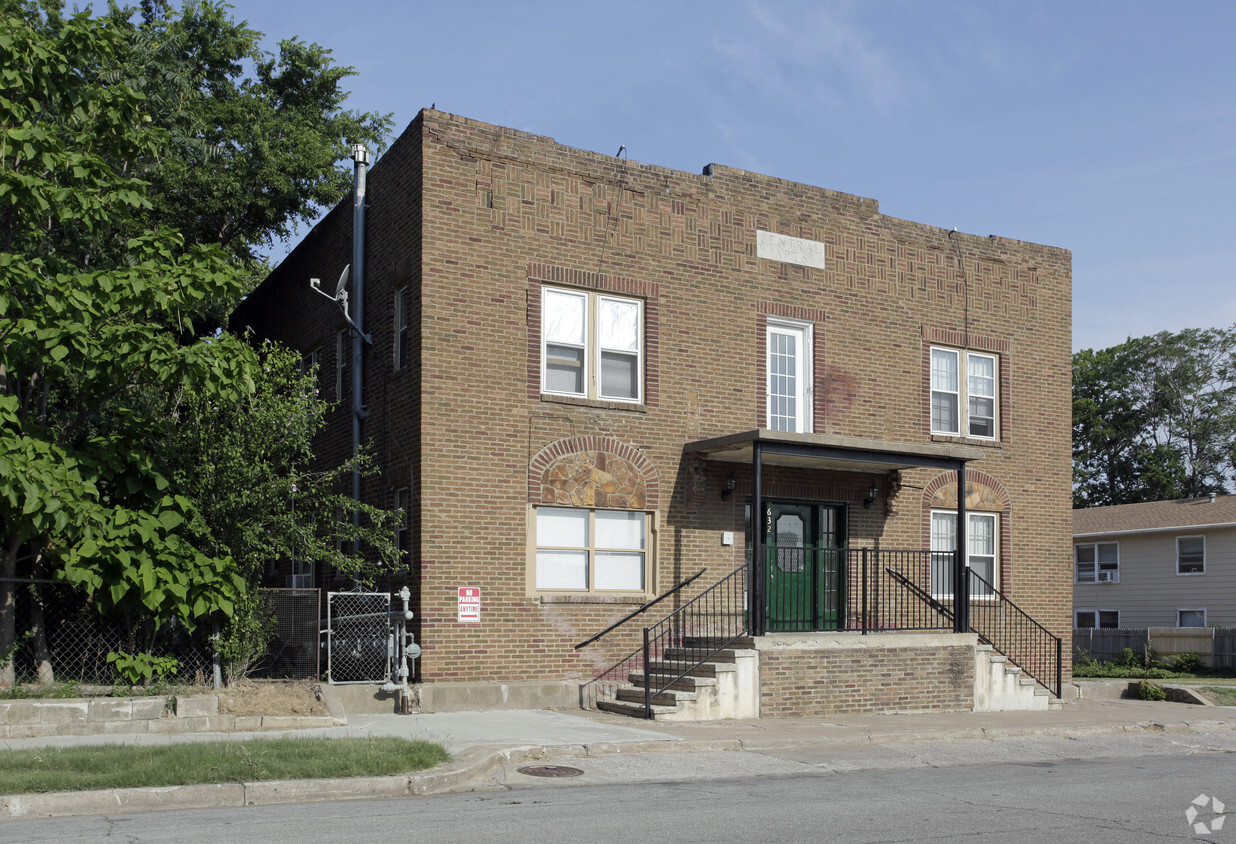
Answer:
[{"xmin": 108, "ymin": 0, "xmax": 392, "ymax": 264}]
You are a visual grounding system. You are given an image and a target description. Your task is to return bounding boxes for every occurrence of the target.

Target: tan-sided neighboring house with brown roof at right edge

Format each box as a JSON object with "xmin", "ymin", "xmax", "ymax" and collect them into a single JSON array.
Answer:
[{"xmin": 1073, "ymin": 496, "xmax": 1236, "ymax": 628}]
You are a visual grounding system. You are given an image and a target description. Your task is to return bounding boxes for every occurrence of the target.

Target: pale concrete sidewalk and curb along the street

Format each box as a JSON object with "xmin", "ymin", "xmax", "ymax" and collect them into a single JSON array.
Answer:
[{"xmin": 0, "ymin": 701, "xmax": 1236, "ymax": 819}]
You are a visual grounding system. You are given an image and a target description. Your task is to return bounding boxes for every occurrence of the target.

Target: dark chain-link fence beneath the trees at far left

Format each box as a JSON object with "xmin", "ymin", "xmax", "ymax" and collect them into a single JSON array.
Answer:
[{"xmin": 0, "ymin": 580, "xmax": 211, "ymax": 686}]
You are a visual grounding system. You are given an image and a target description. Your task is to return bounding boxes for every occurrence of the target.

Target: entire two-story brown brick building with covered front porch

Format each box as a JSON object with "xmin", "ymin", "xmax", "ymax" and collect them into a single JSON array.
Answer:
[{"xmin": 232, "ymin": 110, "xmax": 1072, "ymax": 714}]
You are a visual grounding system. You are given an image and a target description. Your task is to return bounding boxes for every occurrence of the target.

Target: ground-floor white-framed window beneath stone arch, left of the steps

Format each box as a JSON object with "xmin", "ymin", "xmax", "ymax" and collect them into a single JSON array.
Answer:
[{"xmin": 534, "ymin": 507, "xmax": 649, "ymax": 593}]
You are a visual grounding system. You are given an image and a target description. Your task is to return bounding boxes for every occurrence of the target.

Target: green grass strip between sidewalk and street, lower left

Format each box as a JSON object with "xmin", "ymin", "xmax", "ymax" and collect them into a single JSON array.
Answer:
[{"xmin": 0, "ymin": 738, "xmax": 450, "ymax": 795}]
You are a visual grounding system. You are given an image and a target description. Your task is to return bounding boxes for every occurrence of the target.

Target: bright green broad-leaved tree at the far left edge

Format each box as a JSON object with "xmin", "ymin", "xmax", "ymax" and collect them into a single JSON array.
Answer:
[{"xmin": 0, "ymin": 1, "xmax": 391, "ymax": 682}]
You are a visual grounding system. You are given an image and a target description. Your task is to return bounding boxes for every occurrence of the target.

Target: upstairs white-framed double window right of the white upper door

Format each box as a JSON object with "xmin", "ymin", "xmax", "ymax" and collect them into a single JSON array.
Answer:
[{"xmin": 931, "ymin": 346, "xmax": 1000, "ymax": 440}]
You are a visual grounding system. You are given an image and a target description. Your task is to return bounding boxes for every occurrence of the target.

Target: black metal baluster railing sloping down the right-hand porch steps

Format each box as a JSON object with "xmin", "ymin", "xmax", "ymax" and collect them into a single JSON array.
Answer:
[{"xmin": 970, "ymin": 568, "xmax": 1062, "ymax": 697}]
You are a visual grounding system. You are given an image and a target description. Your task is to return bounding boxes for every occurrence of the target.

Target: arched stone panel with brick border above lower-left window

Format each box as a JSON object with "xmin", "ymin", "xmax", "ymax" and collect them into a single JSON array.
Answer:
[{"xmin": 528, "ymin": 436, "xmax": 661, "ymax": 510}]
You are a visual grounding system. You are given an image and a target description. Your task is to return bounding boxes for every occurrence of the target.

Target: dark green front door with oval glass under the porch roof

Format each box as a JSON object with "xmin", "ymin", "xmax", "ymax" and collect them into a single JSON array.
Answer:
[{"xmin": 763, "ymin": 500, "xmax": 845, "ymax": 631}]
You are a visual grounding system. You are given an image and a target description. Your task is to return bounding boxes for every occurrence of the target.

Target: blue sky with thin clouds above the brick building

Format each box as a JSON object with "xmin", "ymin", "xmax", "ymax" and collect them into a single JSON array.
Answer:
[{"xmin": 235, "ymin": 0, "xmax": 1236, "ymax": 348}]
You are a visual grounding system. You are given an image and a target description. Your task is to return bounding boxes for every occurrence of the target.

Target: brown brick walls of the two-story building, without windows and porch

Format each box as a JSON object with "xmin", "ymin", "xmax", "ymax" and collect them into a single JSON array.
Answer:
[{"xmin": 234, "ymin": 110, "xmax": 1072, "ymax": 709}]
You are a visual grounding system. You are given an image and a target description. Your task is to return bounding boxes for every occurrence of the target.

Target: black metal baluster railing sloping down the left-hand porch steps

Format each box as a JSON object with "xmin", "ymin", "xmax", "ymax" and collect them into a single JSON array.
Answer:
[{"xmin": 643, "ymin": 566, "xmax": 748, "ymax": 718}]
